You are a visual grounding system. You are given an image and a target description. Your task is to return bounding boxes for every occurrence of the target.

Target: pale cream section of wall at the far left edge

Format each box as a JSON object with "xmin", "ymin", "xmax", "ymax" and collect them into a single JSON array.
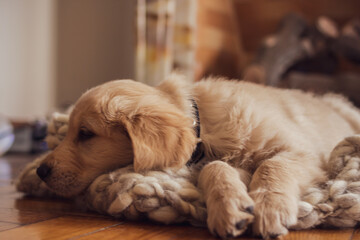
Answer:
[{"xmin": 0, "ymin": 0, "xmax": 55, "ymax": 118}]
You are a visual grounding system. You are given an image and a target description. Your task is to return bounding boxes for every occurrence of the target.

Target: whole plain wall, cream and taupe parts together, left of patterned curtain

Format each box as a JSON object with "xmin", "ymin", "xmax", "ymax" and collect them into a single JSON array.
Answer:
[{"xmin": 0, "ymin": 0, "xmax": 136, "ymax": 119}]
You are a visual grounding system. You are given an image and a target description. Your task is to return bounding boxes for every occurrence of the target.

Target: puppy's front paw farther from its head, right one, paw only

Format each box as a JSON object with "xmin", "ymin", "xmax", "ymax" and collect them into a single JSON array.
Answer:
[{"xmin": 250, "ymin": 192, "xmax": 298, "ymax": 239}]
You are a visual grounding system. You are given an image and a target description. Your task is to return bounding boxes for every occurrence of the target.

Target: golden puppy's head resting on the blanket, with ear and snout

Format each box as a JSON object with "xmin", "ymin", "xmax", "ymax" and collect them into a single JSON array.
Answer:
[{"xmin": 37, "ymin": 80, "xmax": 196, "ymax": 197}]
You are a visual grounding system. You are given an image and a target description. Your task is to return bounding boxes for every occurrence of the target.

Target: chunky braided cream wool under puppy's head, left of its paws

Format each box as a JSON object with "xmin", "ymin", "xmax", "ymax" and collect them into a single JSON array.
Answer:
[{"xmin": 16, "ymin": 113, "xmax": 207, "ymax": 226}]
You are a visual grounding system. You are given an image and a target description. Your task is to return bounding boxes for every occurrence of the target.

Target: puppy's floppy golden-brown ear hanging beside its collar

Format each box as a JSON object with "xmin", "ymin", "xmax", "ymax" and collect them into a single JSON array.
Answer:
[{"xmin": 126, "ymin": 105, "xmax": 196, "ymax": 172}]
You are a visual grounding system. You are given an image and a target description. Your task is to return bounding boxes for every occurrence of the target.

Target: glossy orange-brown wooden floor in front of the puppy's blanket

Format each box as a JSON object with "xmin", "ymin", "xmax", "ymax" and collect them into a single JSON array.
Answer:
[{"xmin": 0, "ymin": 155, "xmax": 360, "ymax": 240}]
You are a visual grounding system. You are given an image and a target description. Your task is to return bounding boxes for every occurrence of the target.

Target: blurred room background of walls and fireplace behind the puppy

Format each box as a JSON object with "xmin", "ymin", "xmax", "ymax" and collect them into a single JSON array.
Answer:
[{"xmin": 0, "ymin": 0, "xmax": 360, "ymax": 153}]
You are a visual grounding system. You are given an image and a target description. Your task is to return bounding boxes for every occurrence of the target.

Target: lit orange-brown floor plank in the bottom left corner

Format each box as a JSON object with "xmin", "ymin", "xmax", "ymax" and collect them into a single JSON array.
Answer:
[{"xmin": 0, "ymin": 216, "xmax": 122, "ymax": 240}]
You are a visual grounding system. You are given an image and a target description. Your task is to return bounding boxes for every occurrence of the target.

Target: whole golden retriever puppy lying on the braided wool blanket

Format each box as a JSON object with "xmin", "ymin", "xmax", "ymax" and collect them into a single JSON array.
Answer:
[{"xmin": 37, "ymin": 75, "xmax": 360, "ymax": 238}]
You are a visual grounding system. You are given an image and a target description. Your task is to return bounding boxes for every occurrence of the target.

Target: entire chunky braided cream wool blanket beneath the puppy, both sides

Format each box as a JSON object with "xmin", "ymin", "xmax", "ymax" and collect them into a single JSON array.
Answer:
[{"xmin": 16, "ymin": 113, "xmax": 360, "ymax": 230}]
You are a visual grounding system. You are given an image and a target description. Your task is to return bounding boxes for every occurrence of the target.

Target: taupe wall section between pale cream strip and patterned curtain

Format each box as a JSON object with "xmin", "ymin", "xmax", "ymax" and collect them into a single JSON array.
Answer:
[{"xmin": 56, "ymin": 0, "xmax": 136, "ymax": 106}]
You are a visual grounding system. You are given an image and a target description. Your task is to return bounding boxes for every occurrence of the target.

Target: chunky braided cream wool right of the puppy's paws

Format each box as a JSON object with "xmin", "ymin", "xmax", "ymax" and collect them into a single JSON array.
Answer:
[{"xmin": 291, "ymin": 135, "xmax": 360, "ymax": 229}]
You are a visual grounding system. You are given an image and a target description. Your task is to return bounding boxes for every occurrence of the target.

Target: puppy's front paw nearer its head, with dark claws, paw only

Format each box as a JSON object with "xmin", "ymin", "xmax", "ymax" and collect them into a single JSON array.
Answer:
[{"xmin": 207, "ymin": 192, "xmax": 254, "ymax": 238}]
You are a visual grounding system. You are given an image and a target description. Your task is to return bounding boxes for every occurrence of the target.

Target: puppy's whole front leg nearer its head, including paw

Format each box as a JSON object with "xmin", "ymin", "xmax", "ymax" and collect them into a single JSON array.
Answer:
[{"xmin": 199, "ymin": 161, "xmax": 254, "ymax": 238}]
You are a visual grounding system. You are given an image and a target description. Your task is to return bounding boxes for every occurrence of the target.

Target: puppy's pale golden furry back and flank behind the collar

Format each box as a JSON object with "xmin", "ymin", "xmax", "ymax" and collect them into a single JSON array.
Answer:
[{"xmin": 194, "ymin": 79, "xmax": 360, "ymax": 161}]
